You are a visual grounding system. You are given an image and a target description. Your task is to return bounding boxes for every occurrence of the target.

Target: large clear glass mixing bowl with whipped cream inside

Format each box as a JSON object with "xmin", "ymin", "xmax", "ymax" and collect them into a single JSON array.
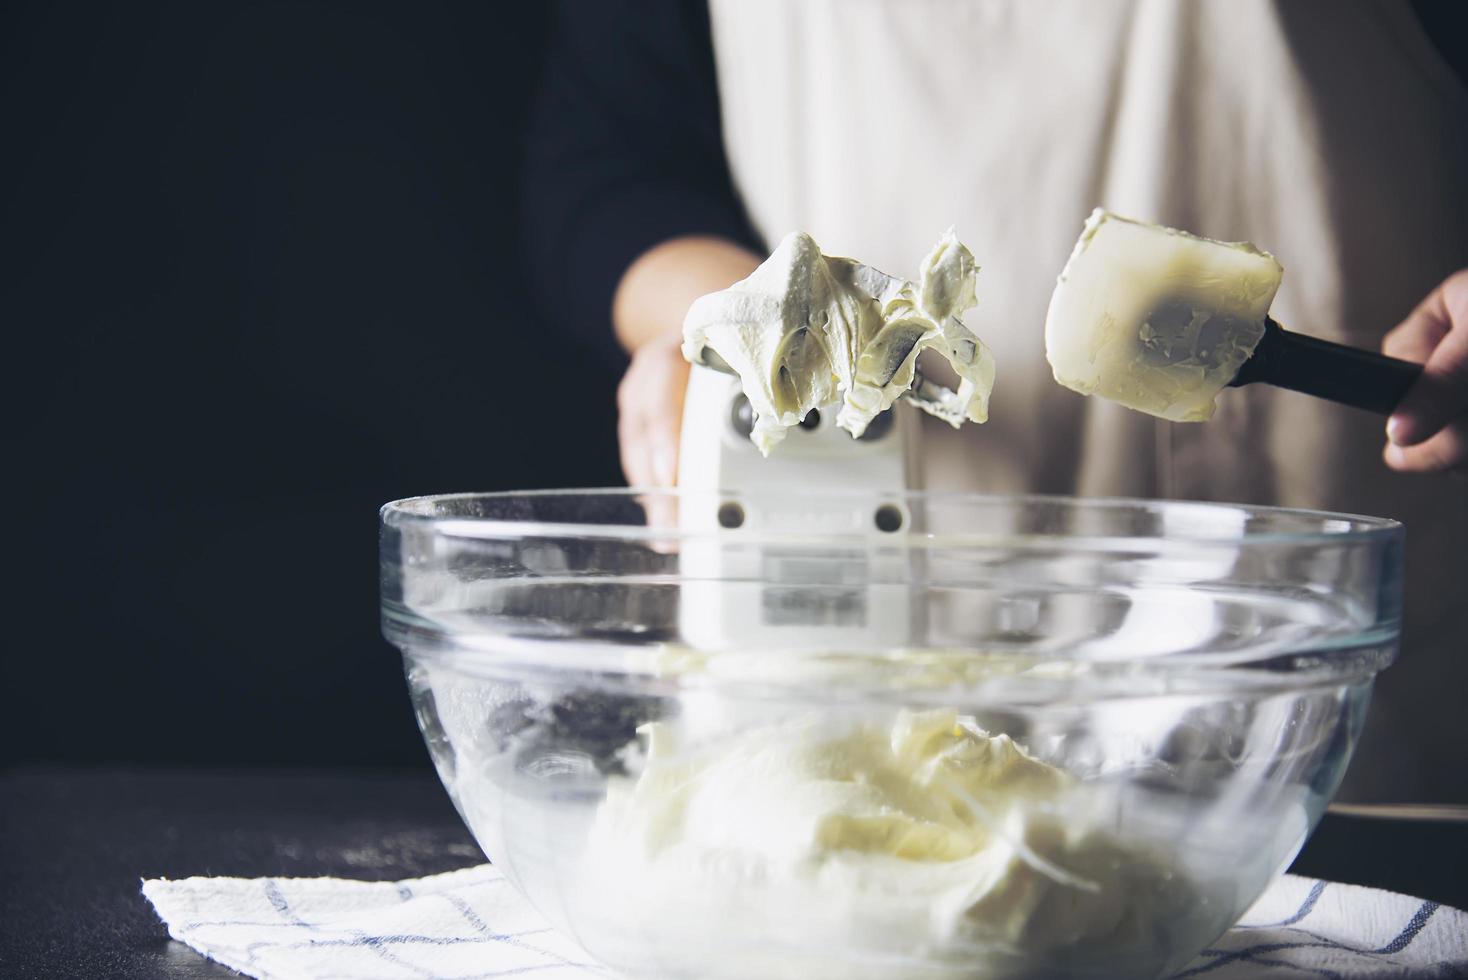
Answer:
[{"xmin": 382, "ymin": 491, "xmax": 1402, "ymax": 980}]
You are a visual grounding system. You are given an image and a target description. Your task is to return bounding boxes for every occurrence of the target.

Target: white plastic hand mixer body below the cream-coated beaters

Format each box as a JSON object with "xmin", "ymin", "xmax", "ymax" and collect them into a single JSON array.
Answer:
[{"xmin": 678, "ymin": 365, "xmax": 918, "ymax": 648}]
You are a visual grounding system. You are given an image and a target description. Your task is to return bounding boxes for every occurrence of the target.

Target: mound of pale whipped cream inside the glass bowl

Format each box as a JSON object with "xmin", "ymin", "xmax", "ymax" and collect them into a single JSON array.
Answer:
[{"xmin": 583, "ymin": 710, "xmax": 1226, "ymax": 979}]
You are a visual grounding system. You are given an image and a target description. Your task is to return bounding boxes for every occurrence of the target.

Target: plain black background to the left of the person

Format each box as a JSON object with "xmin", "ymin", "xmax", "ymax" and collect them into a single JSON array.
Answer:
[{"xmin": 0, "ymin": 0, "xmax": 619, "ymax": 767}]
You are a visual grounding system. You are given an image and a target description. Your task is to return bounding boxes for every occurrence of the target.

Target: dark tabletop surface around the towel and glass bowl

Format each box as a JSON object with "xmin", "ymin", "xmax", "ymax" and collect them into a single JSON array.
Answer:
[{"xmin": 0, "ymin": 770, "xmax": 1468, "ymax": 980}]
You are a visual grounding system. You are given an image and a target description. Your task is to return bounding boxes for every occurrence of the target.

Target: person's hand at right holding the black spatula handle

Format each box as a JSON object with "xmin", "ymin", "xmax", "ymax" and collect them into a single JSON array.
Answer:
[{"xmin": 1381, "ymin": 268, "xmax": 1468, "ymax": 472}]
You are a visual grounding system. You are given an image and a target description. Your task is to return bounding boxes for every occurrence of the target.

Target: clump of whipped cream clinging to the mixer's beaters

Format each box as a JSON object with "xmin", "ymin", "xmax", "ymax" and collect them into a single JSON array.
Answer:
[{"xmin": 683, "ymin": 230, "xmax": 994, "ymax": 455}]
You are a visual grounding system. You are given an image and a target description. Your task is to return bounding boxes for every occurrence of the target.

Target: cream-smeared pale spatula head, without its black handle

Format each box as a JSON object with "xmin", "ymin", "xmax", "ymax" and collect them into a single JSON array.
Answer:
[{"xmin": 1045, "ymin": 208, "xmax": 1283, "ymax": 423}]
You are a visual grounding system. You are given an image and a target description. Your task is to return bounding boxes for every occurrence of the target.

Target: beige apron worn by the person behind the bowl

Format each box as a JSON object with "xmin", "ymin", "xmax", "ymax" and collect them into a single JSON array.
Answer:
[{"xmin": 711, "ymin": 0, "xmax": 1468, "ymax": 802}]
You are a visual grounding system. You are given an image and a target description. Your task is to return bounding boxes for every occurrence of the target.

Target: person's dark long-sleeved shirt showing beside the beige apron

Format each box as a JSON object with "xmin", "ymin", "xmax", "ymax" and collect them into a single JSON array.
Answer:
[{"xmin": 521, "ymin": 0, "xmax": 1468, "ymax": 369}]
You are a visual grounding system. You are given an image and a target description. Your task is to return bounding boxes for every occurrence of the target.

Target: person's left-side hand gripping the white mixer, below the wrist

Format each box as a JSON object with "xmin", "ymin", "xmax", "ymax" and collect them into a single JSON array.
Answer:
[{"xmin": 617, "ymin": 330, "xmax": 688, "ymax": 487}]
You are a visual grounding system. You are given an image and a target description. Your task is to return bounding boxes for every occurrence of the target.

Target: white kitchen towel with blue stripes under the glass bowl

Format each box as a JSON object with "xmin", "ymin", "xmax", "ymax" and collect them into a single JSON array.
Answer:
[{"xmin": 142, "ymin": 864, "xmax": 1468, "ymax": 980}]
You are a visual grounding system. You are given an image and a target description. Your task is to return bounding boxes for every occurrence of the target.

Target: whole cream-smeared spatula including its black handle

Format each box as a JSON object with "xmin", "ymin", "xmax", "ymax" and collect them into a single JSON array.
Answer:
[{"xmin": 1045, "ymin": 208, "xmax": 1422, "ymax": 423}]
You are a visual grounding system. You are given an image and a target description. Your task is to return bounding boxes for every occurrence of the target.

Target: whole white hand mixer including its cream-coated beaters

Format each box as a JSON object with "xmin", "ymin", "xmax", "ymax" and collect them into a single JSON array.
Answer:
[{"xmin": 678, "ymin": 232, "xmax": 994, "ymax": 648}]
